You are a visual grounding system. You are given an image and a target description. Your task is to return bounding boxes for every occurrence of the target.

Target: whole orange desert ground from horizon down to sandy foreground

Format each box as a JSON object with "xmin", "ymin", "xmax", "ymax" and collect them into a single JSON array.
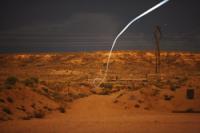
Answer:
[{"xmin": 0, "ymin": 51, "xmax": 200, "ymax": 133}]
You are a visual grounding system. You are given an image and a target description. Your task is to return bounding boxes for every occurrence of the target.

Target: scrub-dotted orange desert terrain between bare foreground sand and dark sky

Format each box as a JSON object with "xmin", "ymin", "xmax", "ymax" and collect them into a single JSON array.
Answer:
[{"xmin": 0, "ymin": 51, "xmax": 200, "ymax": 119}]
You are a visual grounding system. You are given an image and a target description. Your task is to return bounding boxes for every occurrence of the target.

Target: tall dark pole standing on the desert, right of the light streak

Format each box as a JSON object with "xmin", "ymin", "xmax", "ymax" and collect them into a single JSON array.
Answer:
[{"xmin": 154, "ymin": 25, "xmax": 161, "ymax": 74}]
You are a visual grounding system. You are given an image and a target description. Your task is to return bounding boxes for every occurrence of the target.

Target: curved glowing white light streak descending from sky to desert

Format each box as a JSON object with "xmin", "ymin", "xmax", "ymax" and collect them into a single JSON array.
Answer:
[{"xmin": 93, "ymin": 0, "xmax": 169, "ymax": 88}]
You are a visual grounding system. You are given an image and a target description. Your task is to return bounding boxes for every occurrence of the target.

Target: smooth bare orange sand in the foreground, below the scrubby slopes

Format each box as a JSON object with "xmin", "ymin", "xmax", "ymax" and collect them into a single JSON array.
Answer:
[{"xmin": 0, "ymin": 94, "xmax": 200, "ymax": 133}]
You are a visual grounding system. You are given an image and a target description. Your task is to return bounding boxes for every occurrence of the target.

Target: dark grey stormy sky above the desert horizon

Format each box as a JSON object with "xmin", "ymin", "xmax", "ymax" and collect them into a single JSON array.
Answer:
[{"xmin": 0, "ymin": 0, "xmax": 200, "ymax": 52}]
